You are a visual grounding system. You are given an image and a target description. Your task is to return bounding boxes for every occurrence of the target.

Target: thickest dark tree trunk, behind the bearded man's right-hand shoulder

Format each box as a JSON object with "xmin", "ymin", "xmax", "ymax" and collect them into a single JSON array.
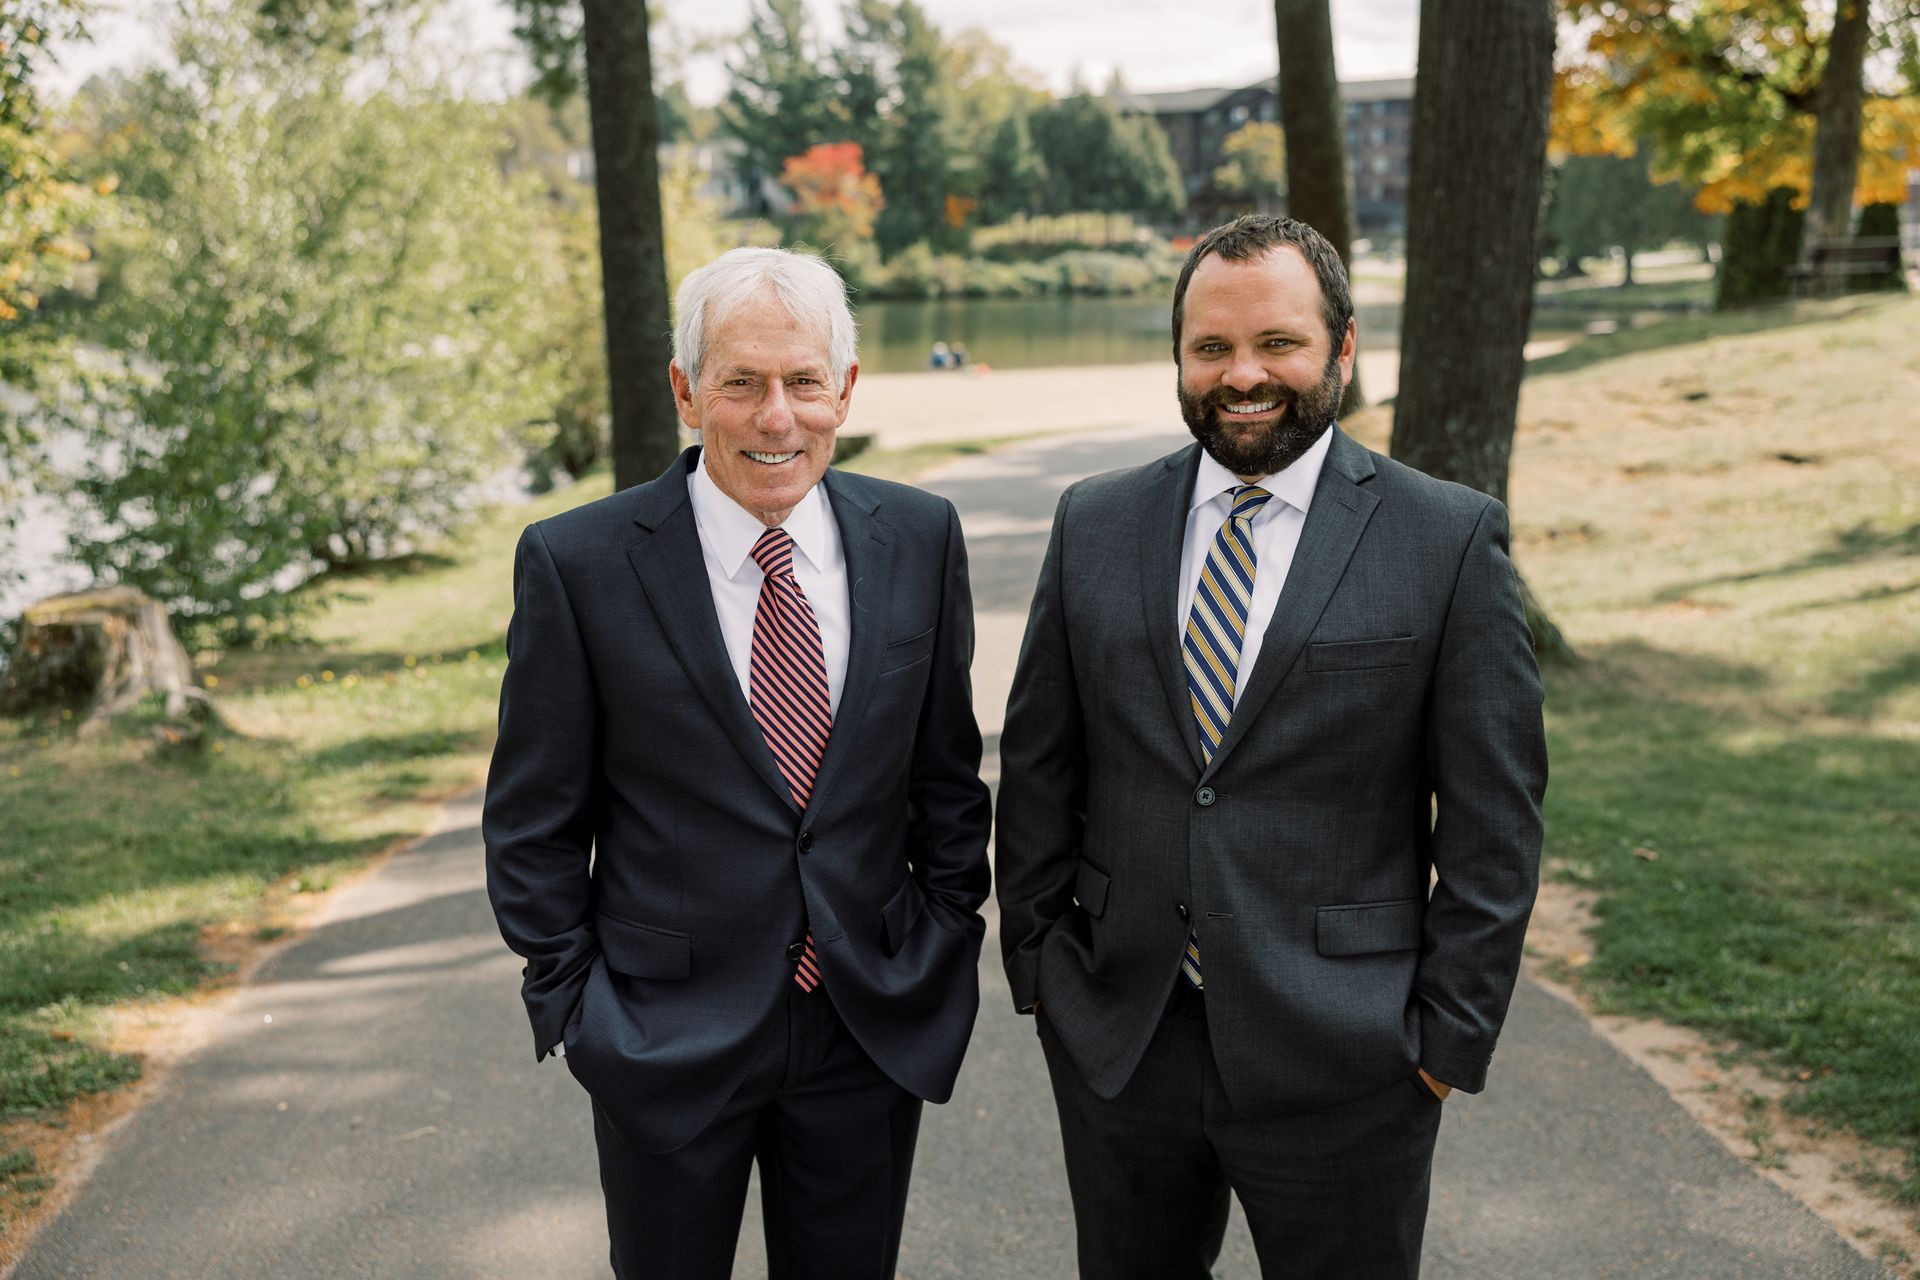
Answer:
[{"xmin": 1392, "ymin": 0, "xmax": 1565, "ymax": 654}]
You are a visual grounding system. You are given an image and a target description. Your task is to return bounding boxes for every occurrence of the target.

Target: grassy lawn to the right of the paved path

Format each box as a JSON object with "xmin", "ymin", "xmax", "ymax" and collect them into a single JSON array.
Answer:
[{"xmin": 1513, "ymin": 297, "xmax": 1920, "ymax": 1205}]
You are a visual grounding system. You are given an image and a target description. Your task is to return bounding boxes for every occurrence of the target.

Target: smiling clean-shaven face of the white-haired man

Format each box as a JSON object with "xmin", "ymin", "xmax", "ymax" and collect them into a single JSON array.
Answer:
[{"xmin": 668, "ymin": 294, "xmax": 860, "ymax": 528}]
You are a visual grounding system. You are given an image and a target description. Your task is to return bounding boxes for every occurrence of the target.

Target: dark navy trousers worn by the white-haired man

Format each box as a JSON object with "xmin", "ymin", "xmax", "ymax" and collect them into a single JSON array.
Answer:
[{"xmin": 593, "ymin": 986, "xmax": 920, "ymax": 1280}]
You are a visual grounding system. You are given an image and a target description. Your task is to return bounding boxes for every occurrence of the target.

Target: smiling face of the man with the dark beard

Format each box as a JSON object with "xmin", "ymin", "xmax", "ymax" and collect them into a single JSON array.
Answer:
[{"xmin": 1179, "ymin": 246, "xmax": 1354, "ymax": 482}]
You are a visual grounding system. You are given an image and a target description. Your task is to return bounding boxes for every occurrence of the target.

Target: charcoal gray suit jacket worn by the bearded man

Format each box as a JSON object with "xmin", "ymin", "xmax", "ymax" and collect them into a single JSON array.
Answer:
[{"xmin": 996, "ymin": 428, "xmax": 1546, "ymax": 1115}]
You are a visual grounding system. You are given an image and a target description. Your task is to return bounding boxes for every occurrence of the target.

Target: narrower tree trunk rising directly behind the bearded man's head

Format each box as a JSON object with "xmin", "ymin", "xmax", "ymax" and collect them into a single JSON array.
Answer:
[{"xmin": 1273, "ymin": 0, "xmax": 1367, "ymax": 413}]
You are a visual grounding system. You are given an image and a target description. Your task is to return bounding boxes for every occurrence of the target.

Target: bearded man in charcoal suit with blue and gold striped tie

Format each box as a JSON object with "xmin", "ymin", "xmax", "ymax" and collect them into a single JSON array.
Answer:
[{"xmin": 996, "ymin": 215, "xmax": 1546, "ymax": 1280}]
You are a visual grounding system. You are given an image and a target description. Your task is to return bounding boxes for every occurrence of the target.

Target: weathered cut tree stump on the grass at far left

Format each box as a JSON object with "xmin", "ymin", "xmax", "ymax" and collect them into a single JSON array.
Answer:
[{"xmin": 0, "ymin": 587, "xmax": 219, "ymax": 733}]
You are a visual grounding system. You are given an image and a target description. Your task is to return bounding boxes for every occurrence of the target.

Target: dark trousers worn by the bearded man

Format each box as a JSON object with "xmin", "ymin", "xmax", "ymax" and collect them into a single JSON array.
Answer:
[{"xmin": 1039, "ymin": 981, "xmax": 1442, "ymax": 1280}]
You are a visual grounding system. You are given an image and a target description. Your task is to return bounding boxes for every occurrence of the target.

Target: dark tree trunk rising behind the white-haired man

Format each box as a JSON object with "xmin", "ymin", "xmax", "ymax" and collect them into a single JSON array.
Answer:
[{"xmin": 584, "ymin": 0, "xmax": 680, "ymax": 489}]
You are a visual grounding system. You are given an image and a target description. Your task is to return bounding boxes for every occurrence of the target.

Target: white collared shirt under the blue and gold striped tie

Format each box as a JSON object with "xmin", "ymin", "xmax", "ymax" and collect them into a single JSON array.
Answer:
[{"xmin": 1173, "ymin": 426, "xmax": 1332, "ymax": 699}]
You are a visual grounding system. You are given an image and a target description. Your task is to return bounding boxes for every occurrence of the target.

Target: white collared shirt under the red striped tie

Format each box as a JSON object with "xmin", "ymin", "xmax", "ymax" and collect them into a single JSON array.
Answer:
[{"xmin": 687, "ymin": 453, "xmax": 852, "ymax": 716}]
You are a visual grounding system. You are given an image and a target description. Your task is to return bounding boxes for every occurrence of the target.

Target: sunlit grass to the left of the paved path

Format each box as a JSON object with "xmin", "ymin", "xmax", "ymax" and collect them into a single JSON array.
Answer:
[{"xmin": 0, "ymin": 433, "xmax": 1000, "ymax": 1263}]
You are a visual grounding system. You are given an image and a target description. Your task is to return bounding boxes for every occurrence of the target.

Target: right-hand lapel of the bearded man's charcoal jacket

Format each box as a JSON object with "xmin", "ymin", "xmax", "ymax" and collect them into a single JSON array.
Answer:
[{"xmin": 1205, "ymin": 426, "xmax": 1380, "ymax": 777}]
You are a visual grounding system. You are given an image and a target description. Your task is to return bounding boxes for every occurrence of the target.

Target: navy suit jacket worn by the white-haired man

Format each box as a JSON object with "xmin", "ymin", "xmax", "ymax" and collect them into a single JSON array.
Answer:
[{"xmin": 482, "ymin": 449, "xmax": 991, "ymax": 1151}]
